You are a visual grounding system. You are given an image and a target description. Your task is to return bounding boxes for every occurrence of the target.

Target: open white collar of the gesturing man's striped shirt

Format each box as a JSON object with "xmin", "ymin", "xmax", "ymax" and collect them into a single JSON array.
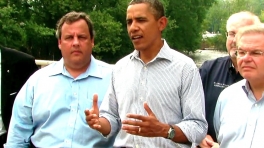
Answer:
[{"xmin": 130, "ymin": 39, "xmax": 172, "ymax": 61}]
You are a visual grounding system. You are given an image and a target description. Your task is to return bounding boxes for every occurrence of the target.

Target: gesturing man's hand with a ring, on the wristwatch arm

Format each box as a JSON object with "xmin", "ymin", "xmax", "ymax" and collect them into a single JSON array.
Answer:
[{"xmin": 122, "ymin": 103, "xmax": 167, "ymax": 137}]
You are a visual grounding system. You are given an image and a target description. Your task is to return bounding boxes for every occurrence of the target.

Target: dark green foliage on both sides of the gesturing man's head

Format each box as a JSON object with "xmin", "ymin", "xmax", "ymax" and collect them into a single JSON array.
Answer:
[{"xmin": 0, "ymin": 0, "xmax": 219, "ymax": 63}]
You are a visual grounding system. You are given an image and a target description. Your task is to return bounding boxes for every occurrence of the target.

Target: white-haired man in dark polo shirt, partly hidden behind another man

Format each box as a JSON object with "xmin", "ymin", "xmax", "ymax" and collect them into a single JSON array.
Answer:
[{"xmin": 199, "ymin": 11, "xmax": 260, "ymax": 148}]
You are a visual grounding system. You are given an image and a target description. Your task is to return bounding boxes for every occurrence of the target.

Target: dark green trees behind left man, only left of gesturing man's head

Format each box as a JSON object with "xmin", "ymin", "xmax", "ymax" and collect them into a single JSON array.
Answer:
[{"xmin": 0, "ymin": 0, "xmax": 125, "ymax": 62}]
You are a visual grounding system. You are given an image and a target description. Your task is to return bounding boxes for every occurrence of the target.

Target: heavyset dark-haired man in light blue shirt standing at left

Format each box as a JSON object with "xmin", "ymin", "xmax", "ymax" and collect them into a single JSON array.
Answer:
[{"xmin": 5, "ymin": 12, "xmax": 115, "ymax": 148}]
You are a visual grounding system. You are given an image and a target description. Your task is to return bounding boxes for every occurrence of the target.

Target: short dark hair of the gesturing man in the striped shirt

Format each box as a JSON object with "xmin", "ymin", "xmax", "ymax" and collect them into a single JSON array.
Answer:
[{"xmin": 128, "ymin": 0, "xmax": 165, "ymax": 19}]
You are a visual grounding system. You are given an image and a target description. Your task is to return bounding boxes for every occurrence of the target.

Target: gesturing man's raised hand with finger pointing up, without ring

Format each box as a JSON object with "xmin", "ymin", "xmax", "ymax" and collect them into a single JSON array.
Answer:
[{"xmin": 84, "ymin": 94, "xmax": 101, "ymax": 130}]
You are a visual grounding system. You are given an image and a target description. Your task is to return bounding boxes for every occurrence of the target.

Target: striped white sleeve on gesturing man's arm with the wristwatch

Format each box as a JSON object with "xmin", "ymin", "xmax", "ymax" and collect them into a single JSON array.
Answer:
[{"xmin": 177, "ymin": 65, "xmax": 208, "ymax": 144}]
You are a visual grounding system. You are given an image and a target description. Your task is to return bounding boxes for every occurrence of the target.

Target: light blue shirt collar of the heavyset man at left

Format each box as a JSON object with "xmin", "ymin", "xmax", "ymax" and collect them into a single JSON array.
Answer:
[{"xmin": 50, "ymin": 55, "xmax": 103, "ymax": 79}]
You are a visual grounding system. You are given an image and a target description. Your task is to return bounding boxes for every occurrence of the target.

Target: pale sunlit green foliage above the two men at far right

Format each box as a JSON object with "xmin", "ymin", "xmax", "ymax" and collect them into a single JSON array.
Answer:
[{"xmin": 203, "ymin": 0, "xmax": 264, "ymax": 51}]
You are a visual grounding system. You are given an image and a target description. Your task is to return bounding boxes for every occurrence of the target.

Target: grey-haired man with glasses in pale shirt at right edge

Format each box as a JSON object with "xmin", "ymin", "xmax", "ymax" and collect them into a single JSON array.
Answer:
[{"xmin": 214, "ymin": 25, "xmax": 264, "ymax": 148}]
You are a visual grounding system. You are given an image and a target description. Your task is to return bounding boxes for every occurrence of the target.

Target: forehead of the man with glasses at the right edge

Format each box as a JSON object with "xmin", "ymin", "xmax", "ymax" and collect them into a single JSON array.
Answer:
[{"xmin": 238, "ymin": 33, "xmax": 264, "ymax": 50}]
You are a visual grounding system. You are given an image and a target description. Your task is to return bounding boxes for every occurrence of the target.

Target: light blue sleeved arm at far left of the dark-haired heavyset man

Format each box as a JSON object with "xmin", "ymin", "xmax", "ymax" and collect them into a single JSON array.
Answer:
[{"xmin": 5, "ymin": 82, "xmax": 34, "ymax": 148}]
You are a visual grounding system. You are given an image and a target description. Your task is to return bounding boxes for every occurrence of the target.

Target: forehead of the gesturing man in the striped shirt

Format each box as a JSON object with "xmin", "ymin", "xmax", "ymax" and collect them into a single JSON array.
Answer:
[{"xmin": 127, "ymin": 3, "xmax": 154, "ymax": 18}]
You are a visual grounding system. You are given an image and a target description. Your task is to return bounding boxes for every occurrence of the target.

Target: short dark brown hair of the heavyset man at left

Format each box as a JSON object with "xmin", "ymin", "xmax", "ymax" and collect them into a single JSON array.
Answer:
[{"xmin": 56, "ymin": 11, "xmax": 94, "ymax": 39}]
